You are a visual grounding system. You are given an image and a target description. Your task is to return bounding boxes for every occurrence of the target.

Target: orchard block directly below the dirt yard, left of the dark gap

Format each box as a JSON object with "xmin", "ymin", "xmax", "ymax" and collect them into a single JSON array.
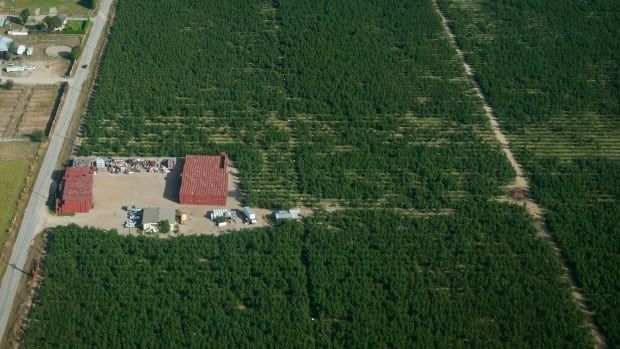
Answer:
[{"xmin": 25, "ymin": 224, "xmax": 312, "ymax": 348}]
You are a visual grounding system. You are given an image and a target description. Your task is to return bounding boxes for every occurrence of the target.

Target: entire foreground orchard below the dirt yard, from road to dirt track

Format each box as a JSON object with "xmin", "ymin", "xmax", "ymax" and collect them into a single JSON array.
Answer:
[{"xmin": 25, "ymin": 204, "xmax": 591, "ymax": 348}]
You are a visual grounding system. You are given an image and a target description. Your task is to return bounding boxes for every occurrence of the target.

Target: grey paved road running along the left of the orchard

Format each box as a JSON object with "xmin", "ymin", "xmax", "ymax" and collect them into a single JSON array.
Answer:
[{"xmin": 0, "ymin": 0, "xmax": 112, "ymax": 338}]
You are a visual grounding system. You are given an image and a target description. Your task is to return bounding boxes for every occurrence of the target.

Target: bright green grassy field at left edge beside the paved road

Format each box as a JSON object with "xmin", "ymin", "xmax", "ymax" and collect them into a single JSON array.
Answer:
[{"xmin": 0, "ymin": 160, "xmax": 28, "ymax": 250}]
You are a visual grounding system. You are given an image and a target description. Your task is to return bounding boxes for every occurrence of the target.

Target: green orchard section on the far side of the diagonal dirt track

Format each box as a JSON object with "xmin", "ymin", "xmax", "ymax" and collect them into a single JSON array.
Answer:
[{"xmin": 439, "ymin": 0, "xmax": 620, "ymax": 347}]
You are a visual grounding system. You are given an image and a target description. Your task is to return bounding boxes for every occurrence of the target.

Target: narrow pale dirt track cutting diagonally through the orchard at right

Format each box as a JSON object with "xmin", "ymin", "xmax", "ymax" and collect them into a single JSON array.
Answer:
[{"xmin": 433, "ymin": 0, "xmax": 607, "ymax": 348}]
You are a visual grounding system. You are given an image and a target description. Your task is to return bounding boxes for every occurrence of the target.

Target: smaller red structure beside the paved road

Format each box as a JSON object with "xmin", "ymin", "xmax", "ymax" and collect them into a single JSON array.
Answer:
[{"xmin": 56, "ymin": 167, "xmax": 94, "ymax": 213}]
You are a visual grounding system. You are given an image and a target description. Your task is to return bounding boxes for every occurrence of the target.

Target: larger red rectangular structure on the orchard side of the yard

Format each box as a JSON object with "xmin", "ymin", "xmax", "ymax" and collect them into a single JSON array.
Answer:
[{"xmin": 179, "ymin": 153, "xmax": 228, "ymax": 206}]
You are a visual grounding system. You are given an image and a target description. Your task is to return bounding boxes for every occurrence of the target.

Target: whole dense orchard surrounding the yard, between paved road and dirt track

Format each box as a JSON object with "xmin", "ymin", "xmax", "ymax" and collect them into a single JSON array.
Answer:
[{"xmin": 21, "ymin": 0, "xmax": 613, "ymax": 348}]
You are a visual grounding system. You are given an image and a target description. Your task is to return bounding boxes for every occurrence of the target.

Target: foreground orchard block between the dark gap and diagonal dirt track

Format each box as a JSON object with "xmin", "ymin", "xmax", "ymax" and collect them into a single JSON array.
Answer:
[{"xmin": 304, "ymin": 202, "xmax": 591, "ymax": 348}]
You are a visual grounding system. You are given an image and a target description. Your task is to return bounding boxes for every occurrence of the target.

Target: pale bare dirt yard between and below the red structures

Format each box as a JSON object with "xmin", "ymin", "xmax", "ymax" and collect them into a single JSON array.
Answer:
[{"xmin": 47, "ymin": 165, "xmax": 286, "ymax": 236}]
